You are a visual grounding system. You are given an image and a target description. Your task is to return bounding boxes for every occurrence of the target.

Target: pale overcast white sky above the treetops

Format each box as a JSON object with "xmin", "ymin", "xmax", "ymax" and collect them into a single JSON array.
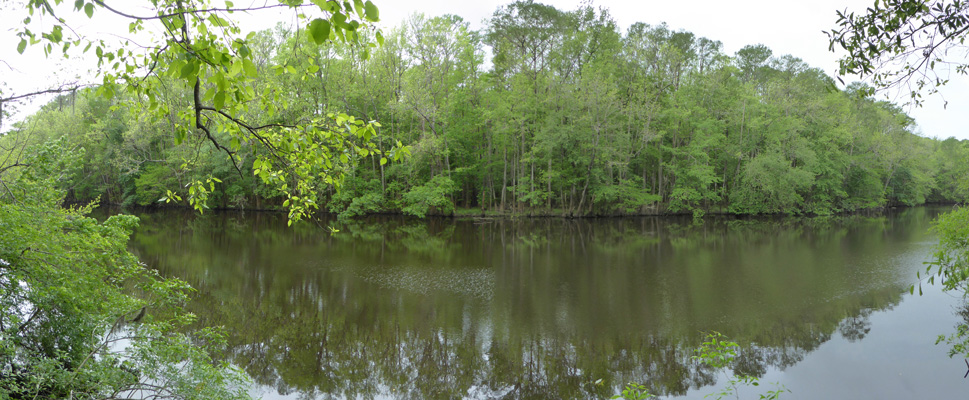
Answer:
[{"xmin": 0, "ymin": 0, "xmax": 969, "ymax": 139}]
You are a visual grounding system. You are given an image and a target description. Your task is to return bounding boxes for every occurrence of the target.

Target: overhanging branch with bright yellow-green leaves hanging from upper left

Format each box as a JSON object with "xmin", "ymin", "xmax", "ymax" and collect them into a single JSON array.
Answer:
[{"xmin": 3, "ymin": 0, "xmax": 394, "ymax": 220}]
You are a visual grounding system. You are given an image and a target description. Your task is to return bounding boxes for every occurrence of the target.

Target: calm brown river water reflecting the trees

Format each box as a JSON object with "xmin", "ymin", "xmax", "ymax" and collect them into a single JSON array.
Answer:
[{"xmin": 125, "ymin": 208, "xmax": 969, "ymax": 399}]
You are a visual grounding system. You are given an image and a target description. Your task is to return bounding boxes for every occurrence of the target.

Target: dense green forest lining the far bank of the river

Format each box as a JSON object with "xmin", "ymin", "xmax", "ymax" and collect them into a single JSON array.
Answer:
[{"xmin": 0, "ymin": 1, "xmax": 969, "ymax": 217}]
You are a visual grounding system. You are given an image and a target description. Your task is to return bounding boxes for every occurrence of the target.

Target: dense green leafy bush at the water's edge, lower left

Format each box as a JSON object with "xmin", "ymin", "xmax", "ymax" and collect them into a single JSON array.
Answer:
[{"xmin": 0, "ymin": 141, "xmax": 248, "ymax": 399}]
